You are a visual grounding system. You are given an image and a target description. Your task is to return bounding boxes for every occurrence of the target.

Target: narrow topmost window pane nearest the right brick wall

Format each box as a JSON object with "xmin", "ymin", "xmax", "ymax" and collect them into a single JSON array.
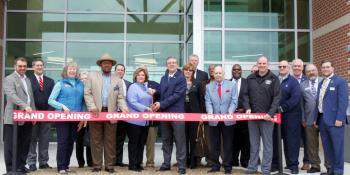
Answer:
[{"xmin": 297, "ymin": 0, "xmax": 310, "ymax": 29}]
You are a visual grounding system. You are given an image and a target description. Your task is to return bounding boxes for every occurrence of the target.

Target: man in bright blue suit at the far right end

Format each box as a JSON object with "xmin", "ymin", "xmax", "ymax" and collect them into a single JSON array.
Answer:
[{"xmin": 315, "ymin": 61, "xmax": 349, "ymax": 175}]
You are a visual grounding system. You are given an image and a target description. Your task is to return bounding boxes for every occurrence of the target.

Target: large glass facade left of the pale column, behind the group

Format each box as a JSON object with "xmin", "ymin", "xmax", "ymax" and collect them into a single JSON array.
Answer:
[{"xmin": 5, "ymin": 0, "xmax": 187, "ymax": 81}]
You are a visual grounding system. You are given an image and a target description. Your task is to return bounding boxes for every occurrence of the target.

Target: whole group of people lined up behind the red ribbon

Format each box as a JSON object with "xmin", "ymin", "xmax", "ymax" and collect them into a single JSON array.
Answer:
[{"xmin": 4, "ymin": 54, "xmax": 348, "ymax": 175}]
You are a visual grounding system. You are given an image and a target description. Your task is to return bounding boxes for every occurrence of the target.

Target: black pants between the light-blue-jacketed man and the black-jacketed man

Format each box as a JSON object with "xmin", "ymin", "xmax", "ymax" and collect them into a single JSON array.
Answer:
[{"xmin": 232, "ymin": 121, "xmax": 250, "ymax": 167}]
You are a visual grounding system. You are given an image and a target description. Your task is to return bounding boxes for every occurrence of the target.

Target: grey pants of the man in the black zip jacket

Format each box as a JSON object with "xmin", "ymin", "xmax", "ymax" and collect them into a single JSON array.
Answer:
[{"xmin": 248, "ymin": 120, "xmax": 274, "ymax": 174}]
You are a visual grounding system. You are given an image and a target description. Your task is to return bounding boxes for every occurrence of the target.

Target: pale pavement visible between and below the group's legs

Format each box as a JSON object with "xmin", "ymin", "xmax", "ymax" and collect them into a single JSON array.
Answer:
[{"xmin": 0, "ymin": 143, "xmax": 350, "ymax": 175}]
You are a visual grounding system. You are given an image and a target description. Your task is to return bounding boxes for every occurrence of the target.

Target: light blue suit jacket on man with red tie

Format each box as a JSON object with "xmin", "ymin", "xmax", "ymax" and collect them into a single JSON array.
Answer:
[{"xmin": 205, "ymin": 80, "xmax": 237, "ymax": 126}]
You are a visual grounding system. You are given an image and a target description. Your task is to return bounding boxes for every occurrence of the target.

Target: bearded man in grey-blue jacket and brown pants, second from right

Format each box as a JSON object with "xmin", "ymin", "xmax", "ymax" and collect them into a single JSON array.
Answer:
[{"xmin": 300, "ymin": 64, "xmax": 329, "ymax": 173}]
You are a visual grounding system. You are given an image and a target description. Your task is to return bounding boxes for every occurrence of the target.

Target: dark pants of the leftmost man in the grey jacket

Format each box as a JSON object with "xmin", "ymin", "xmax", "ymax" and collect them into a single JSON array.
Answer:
[{"xmin": 4, "ymin": 122, "xmax": 32, "ymax": 172}]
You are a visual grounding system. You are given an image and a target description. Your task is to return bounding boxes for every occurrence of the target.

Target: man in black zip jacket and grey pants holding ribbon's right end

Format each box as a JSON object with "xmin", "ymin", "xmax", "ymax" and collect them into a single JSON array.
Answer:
[{"xmin": 243, "ymin": 56, "xmax": 281, "ymax": 175}]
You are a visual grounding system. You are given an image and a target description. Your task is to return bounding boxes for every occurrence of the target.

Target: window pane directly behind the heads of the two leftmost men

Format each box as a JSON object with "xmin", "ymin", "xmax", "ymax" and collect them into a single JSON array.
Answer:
[{"xmin": 5, "ymin": 41, "xmax": 64, "ymax": 68}]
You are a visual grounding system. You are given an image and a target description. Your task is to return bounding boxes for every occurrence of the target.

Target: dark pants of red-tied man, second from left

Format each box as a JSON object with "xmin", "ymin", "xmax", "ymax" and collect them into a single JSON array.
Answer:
[{"xmin": 27, "ymin": 122, "xmax": 51, "ymax": 166}]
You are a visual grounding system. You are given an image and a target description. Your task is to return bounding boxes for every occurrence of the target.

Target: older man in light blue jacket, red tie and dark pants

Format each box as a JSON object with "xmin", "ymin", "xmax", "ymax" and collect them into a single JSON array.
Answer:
[{"xmin": 205, "ymin": 66, "xmax": 237, "ymax": 174}]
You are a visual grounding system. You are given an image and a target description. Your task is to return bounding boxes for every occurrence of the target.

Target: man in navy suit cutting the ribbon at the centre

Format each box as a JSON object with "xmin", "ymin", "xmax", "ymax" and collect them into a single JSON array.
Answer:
[{"xmin": 152, "ymin": 56, "xmax": 186, "ymax": 174}]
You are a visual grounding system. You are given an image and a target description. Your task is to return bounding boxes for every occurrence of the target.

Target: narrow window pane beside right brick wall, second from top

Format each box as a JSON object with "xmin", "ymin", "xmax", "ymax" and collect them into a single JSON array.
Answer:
[{"xmin": 298, "ymin": 32, "xmax": 311, "ymax": 62}]
